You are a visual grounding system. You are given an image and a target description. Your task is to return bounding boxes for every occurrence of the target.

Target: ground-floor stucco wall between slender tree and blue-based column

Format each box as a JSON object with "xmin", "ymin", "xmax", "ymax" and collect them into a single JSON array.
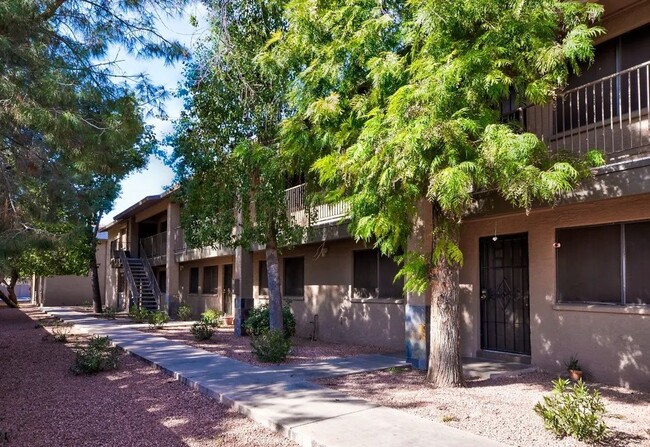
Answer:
[{"xmin": 253, "ymin": 239, "xmax": 404, "ymax": 351}]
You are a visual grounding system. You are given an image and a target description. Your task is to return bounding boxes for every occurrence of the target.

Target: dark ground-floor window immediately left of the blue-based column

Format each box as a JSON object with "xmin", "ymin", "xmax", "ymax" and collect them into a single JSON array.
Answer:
[{"xmin": 352, "ymin": 249, "xmax": 404, "ymax": 298}]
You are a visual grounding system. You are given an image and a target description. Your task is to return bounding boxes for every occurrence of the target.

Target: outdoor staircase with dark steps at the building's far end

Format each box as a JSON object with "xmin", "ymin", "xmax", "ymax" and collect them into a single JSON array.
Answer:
[{"xmin": 120, "ymin": 251, "xmax": 160, "ymax": 311}]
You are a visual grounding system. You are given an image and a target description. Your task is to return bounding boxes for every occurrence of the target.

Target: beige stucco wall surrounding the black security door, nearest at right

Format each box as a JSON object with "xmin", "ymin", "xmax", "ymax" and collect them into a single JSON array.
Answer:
[{"xmin": 461, "ymin": 194, "xmax": 650, "ymax": 388}]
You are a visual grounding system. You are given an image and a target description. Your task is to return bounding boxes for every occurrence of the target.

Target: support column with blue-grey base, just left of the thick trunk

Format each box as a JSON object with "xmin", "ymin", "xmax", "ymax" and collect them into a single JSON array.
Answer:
[{"xmin": 404, "ymin": 199, "xmax": 433, "ymax": 370}]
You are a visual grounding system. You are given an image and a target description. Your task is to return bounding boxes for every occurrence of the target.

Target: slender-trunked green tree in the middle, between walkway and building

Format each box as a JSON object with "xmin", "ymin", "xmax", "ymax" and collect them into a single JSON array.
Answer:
[{"xmin": 166, "ymin": 0, "xmax": 302, "ymax": 330}]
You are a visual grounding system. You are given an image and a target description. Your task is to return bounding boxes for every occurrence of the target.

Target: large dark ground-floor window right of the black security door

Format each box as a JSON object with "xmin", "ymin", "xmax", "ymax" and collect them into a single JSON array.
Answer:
[{"xmin": 556, "ymin": 222, "xmax": 650, "ymax": 304}]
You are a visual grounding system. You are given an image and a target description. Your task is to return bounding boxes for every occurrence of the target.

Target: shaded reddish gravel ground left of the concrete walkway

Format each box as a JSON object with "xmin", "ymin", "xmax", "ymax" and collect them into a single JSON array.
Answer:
[{"xmin": 0, "ymin": 305, "xmax": 296, "ymax": 447}]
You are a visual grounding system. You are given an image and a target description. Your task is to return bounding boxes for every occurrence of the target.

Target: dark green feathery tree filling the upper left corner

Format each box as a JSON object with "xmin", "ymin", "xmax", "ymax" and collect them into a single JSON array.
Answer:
[{"xmin": 0, "ymin": 0, "xmax": 186, "ymax": 311}]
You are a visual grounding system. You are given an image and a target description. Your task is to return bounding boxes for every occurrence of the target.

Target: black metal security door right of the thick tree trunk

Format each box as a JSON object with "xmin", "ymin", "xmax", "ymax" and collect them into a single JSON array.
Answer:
[{"xmin": 479, "ymin": 234, "xmax": 530, "ymax": 355}]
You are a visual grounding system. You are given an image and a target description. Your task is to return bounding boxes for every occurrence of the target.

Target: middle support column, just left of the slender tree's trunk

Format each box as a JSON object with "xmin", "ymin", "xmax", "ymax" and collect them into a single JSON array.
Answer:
[{"xmin": 232, "ymin": 247, "xmax": 255, "ymax": 336}]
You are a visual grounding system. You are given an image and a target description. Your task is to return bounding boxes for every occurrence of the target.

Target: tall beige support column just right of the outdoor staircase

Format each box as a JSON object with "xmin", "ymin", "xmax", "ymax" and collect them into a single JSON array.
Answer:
[{"xmin": 161, "ymin": 202, "xmax": 182, "ymax": 314}]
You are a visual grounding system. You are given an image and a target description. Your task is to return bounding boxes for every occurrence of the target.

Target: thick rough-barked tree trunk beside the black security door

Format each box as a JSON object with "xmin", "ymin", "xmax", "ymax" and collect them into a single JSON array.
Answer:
[{"xmin": 427, "ymin": 204, "xmax": 465, "ymax": 387}]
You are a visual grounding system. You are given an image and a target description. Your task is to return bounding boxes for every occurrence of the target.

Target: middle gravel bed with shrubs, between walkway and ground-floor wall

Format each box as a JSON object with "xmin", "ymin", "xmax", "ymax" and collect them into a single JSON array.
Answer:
[{"xmin": 135, "ymin": 323, "xmax": 391, "ymax": 366}]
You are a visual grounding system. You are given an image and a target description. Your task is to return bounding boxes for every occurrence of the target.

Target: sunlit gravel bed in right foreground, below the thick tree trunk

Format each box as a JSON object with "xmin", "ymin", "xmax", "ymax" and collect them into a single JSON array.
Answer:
[{"xmin": 318, "ymin": 368, "xmax": 650, "ymax": 447}]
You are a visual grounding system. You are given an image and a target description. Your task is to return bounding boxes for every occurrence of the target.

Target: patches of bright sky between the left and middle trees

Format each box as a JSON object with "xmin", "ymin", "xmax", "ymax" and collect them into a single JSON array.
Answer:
[{"xmin": 102, "ymin": 3, "xmax": 208, "ymax": 228}]
